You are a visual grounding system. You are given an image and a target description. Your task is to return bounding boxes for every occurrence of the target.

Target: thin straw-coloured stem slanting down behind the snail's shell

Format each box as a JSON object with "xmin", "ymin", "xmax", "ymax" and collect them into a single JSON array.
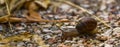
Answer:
[{"xmin": 60, "ymin": 0, "xmax": 111, "ymax": 27}]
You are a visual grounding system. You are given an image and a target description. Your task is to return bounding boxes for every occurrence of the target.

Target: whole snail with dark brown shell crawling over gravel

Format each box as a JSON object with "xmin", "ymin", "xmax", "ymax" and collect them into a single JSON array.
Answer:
[{"xmin": 62, "ymin": 17, "xmax": 97, "ymax": 39}]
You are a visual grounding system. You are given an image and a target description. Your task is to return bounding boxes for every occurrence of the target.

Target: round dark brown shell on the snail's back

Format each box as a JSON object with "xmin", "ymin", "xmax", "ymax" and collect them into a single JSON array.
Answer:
[{"xmin": 76, "ymin": 17, "xmax": 97, "ymax": 34}]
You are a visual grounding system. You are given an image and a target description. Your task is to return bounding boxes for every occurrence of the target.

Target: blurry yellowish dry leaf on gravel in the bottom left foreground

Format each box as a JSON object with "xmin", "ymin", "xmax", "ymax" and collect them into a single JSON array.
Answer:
[{"xmin": 0, "ymin": 33, "xmax": 49, "ymax": 47}]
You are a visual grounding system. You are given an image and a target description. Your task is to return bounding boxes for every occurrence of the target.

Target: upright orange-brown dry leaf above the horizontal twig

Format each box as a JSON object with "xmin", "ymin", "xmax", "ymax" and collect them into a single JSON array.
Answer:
[{"xmin": 26, "ymin": 2, "xmax": 42, "ymax": 21}]
